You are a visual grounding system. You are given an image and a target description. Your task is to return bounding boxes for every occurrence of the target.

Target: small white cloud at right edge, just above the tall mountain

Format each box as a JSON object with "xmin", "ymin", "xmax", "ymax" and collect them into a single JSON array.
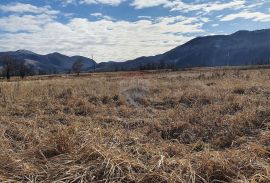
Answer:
[{"xmin": 220, "ymin": 11, "xmax": 270, "ymax": 22}]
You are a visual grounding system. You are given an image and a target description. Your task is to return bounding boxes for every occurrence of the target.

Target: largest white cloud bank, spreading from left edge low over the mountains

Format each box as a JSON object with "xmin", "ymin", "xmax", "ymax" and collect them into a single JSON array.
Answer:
[{"xmin": 0, "ymin": 14, "xmax": 204, "ymax": 61}]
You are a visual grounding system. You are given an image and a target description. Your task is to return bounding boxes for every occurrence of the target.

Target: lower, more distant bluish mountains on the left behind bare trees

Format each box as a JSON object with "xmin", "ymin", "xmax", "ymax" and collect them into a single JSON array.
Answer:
[{"xmin": 0, "ymin": 50, "xmax": 96, "ymax": 73}]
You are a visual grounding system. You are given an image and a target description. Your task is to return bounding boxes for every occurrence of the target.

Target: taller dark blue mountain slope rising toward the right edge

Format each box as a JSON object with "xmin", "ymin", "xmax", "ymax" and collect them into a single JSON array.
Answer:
[{"xmin": 97, "ymin": 29, "xmax": 270, "ymax": 70}]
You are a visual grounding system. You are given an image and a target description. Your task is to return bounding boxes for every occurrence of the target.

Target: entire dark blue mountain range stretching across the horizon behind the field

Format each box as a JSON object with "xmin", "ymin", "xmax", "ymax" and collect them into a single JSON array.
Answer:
[{"xmin": 0, "ymin": 29, "xmax": 270, "ymax": 73}]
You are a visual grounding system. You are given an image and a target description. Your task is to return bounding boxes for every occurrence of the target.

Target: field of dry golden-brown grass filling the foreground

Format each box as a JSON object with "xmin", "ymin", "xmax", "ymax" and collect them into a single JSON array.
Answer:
[{"xmin": 0, "ymin": 69, "xmax": 270, "ymax": 183}]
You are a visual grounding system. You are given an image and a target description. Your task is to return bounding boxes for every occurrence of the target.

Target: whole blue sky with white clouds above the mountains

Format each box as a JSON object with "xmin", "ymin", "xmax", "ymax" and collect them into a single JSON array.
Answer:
[{"xmin": 0, "ymin": 0, "xmax": 270, "ymax": 62}]
